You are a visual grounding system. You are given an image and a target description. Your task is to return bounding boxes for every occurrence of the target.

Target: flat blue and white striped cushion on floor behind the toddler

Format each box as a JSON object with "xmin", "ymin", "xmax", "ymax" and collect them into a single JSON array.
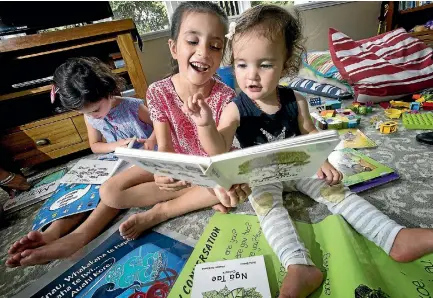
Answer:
[{"xmin": 280, "ymin": 78, "xmax": 352, "ymax": 99}]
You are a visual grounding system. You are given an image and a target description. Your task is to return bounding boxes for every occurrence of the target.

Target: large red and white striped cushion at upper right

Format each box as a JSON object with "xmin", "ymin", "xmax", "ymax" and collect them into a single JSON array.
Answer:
[{"xmin": 329, "ymin": 28, "xmax": 433, "ymax": 102}]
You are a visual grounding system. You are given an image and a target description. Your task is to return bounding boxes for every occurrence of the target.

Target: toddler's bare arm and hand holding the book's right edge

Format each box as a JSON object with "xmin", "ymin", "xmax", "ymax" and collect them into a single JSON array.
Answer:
[{"xmin": 295, "ymin": 93, "xmax": 343, "ymax": 185}]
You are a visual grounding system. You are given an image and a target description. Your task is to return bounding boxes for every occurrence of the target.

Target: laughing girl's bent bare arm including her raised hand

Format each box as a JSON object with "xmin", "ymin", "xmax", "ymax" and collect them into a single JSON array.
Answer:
[{"xmin": 183, "ymin": 94, "xmax": 240, "ymax": 156}]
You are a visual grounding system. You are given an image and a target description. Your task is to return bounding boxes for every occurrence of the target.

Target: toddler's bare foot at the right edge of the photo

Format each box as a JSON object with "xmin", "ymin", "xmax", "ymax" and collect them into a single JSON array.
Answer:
[{"xmin": 389, "ymin": 228, "xmax": 433, "ymax": 263}]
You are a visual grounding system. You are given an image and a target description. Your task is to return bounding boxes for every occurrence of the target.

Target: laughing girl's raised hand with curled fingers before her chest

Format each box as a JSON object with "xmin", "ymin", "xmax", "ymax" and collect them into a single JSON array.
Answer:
[{"xmin": 182, "ymin": 93, "xmax": 213, "ymax": 126}]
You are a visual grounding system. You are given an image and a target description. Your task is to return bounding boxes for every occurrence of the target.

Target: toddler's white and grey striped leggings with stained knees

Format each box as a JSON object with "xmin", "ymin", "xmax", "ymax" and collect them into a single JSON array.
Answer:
[{"xmin": 249, "ymin": 178, "xmax": 403, "ymax": 269}]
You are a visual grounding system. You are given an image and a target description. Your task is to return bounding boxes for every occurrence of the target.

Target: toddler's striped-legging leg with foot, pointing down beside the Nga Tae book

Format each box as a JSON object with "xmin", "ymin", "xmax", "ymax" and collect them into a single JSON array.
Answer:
[{"xmin": 249, "ymin": 183, "xmax": 323, "ymax": 297}]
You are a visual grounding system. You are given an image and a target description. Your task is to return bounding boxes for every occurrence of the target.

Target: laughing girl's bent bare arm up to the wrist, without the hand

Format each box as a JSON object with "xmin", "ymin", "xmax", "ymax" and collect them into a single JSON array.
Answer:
[{"xmin": 197, "ymin": 102, "xmax": 240, "ymax": 156}]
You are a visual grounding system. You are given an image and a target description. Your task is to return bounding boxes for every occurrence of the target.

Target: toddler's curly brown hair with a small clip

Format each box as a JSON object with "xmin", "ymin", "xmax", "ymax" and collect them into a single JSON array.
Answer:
[{"xmin": 227, "ymin": 4, "xmax": 305, "ymax": 75}]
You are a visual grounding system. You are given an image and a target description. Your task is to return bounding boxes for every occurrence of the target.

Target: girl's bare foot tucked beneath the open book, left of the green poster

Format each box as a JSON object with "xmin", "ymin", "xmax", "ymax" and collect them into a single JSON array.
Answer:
[{"xmin": 119, "ymin": 203, "xmax": 168, "ymax": 240}]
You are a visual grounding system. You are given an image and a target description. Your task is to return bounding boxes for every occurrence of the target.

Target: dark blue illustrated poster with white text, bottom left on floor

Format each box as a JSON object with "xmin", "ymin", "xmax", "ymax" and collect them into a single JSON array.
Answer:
[{"xmin": 28, "ymin": 231, "xmax": 193, "ymax": 298}]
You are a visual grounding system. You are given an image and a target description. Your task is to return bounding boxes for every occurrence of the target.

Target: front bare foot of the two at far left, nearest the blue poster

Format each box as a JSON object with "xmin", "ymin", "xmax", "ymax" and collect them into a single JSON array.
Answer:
[{"xmin": 14, "ymin": 233, "xmax": 88, "ymax": 266}]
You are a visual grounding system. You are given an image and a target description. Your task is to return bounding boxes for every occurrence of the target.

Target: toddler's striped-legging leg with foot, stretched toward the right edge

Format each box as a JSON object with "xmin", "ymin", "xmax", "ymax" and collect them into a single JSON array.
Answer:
[{"xmin": 296, "ymin": 179, "xmax": 433, "ymax": 262}]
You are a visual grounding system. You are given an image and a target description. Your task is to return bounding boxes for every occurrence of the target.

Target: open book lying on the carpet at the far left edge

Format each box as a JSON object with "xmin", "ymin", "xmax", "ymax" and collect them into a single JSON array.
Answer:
[{"xmin": 3, "ymin": 169, "xmax": 66, "ymax": 214}]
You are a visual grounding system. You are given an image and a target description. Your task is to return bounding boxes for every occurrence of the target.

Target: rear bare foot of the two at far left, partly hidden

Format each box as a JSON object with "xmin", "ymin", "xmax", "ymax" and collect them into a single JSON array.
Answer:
[{"xmin": 6, "ymin": 231, "xmax": 59, "ymax": 267}]
